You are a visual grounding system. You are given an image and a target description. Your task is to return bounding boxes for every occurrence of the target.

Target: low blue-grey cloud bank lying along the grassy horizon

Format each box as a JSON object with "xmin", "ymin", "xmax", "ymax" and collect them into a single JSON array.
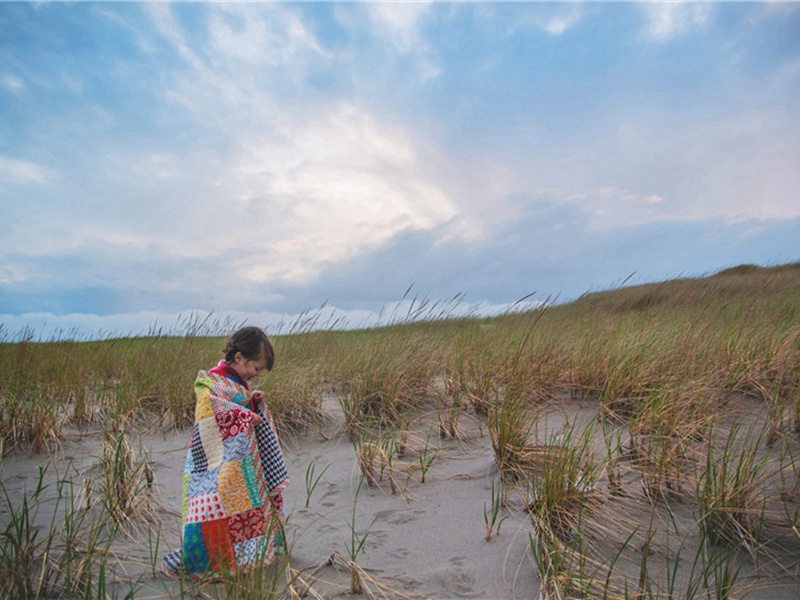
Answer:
[{"xmin": 0, "ymin": 202, "xmax": 800, "ymax": 340}]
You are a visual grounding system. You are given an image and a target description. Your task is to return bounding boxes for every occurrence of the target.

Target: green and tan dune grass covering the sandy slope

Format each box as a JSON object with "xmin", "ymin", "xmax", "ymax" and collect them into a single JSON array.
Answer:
[{"xmin": 0, "ymin": 263, "xmax": 800, "ymax": 598}]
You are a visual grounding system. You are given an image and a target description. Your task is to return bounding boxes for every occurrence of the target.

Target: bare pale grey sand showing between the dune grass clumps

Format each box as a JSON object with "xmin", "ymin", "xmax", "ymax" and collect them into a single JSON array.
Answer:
[{"xmin": 0, "ymin": 398, "xmax": 800, "ymax": 599}]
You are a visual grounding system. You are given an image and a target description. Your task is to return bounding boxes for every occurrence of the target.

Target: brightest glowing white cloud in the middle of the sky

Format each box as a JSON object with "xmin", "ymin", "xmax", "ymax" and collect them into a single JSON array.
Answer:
[{"xmin": 228, "ymin": 106, "xmax": 457, "ymax": 281}]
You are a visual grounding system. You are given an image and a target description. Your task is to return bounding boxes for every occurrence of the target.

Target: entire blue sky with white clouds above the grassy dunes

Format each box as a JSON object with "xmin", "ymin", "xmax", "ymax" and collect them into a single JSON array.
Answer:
[{"xmin": 0, "ymin": 1, "xmax": 800, "ymax": 340}]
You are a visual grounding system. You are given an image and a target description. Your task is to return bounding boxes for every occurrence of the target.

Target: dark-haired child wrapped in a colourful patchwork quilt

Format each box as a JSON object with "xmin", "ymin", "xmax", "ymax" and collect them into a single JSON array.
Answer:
[{"xmin": 162, "ymin": 327, "xmax": 288, "ymax": 576}]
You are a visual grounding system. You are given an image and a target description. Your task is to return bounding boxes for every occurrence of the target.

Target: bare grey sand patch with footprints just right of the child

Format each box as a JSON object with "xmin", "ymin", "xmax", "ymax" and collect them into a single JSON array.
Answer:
[{"xmin": 276, "ymin": 396, "xmax": 537, "ymax": 598}]
